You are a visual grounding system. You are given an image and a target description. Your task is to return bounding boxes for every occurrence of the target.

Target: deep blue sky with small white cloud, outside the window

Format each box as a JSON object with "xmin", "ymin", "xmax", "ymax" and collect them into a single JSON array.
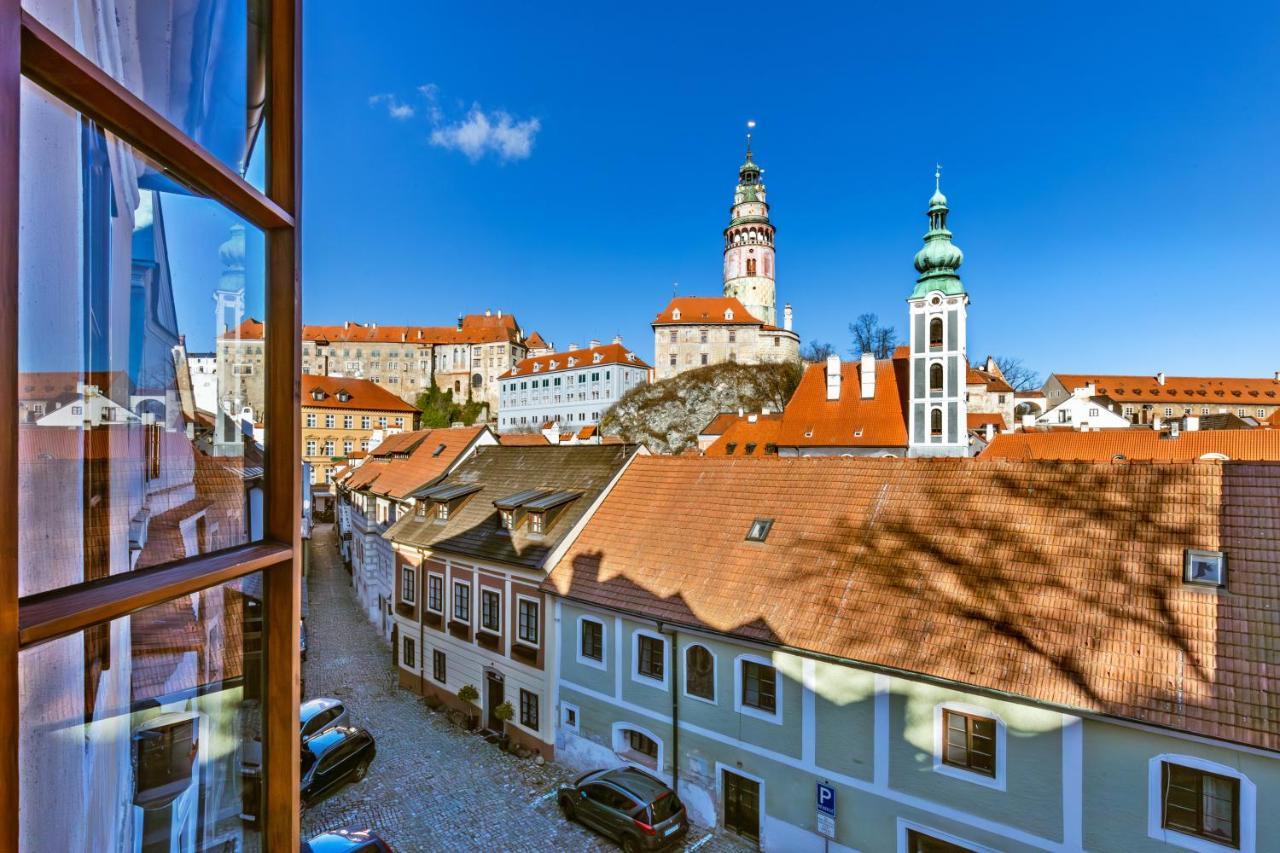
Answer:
[{"xmin": 303, "ymin": 3, "xmax": 1280, "ymax": 375}]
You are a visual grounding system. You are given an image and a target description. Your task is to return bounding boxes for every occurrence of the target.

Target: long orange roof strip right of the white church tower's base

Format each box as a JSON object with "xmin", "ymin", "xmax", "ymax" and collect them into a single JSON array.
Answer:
[{"xmin": 982, "ymin": 428, "xmax": 1280, "ymax": 462}]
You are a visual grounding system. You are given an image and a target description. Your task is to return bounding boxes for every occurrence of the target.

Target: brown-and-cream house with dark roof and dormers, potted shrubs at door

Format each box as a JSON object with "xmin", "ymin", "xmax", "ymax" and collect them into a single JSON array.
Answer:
[{"xmin": 385, "ymin": 444, "xmax": 637, "ymax": 758}]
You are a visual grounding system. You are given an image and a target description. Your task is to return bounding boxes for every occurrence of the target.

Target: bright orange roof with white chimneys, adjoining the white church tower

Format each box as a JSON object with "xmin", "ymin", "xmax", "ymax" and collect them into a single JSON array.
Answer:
[{"xmin": 777, "ymin": 353, "xmax": 908, "ymax": 447}]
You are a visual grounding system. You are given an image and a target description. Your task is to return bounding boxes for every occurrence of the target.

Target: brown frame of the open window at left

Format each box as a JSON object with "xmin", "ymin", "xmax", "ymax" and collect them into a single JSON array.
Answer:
[{"xmin": 0, "ymin": 0, "xmax": 302, "ymax": 850}]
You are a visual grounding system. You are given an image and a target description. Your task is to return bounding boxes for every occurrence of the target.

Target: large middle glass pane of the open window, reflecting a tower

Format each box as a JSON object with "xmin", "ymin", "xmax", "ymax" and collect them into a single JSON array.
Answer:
[{"xmin": 17, "ymin": 82, "xmax": 264, "ymax": 596}]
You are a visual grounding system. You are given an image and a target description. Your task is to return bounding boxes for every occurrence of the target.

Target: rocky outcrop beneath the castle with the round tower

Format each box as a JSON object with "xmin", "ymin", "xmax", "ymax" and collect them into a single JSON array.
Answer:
[{"xmin": 600, "ymin": 362, "xmax": 801, "ymax": 453}]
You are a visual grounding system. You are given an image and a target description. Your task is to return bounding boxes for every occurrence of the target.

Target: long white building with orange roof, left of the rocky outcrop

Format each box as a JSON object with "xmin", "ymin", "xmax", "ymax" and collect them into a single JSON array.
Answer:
[{"xmin": 498, "ymin": 338, "xmax": 649, "ymax": 433}]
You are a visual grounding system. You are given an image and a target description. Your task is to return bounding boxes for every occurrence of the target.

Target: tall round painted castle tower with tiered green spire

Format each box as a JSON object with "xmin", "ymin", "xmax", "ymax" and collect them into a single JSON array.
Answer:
[{"xmin": 724, "ymin": 122, "xmax": 777, "ymax": 325}]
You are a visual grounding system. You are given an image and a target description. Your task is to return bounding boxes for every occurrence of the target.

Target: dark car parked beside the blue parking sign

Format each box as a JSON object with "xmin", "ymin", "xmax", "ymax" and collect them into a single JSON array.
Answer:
[{"xmin": 559, "ymin": 767, "xmax": 689, "ymax": 853}]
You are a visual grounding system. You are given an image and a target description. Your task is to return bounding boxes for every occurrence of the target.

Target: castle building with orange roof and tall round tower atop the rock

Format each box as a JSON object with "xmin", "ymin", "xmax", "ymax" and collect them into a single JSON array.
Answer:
[{"xmin": 652, "ymin": 133, "xmax": 800, "ymax": 379}]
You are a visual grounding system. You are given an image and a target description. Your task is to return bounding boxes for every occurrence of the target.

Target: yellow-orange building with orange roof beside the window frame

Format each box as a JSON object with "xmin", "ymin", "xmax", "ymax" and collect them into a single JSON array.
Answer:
[{"xmin": 302, "ymin": 375, "xmax": 421, "ymax": 484}]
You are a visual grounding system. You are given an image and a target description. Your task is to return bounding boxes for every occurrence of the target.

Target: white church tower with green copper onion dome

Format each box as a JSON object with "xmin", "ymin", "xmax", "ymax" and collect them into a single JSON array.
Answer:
[{"xmin": 906, "ymin": 165, "xmax": 969, "ymax": 456}]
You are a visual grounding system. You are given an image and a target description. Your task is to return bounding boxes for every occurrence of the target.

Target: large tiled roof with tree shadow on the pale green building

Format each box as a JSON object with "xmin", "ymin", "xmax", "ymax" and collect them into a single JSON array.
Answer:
[{"xmin": 544, "ymin": 456, "xmax": 1280, "ymax": 749}]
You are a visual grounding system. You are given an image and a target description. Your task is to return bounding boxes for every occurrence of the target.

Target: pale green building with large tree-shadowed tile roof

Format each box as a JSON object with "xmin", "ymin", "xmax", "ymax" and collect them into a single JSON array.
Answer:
[{"xmin": 544, "ymin": 455, "xmax": 1280, "ymax": 853}]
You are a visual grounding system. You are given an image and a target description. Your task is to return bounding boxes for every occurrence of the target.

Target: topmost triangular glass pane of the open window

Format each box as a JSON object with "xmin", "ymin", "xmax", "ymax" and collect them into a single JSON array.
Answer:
[{"xmin": 22, "ymin": 0, "xmax": 266, "ymax": 190}]
